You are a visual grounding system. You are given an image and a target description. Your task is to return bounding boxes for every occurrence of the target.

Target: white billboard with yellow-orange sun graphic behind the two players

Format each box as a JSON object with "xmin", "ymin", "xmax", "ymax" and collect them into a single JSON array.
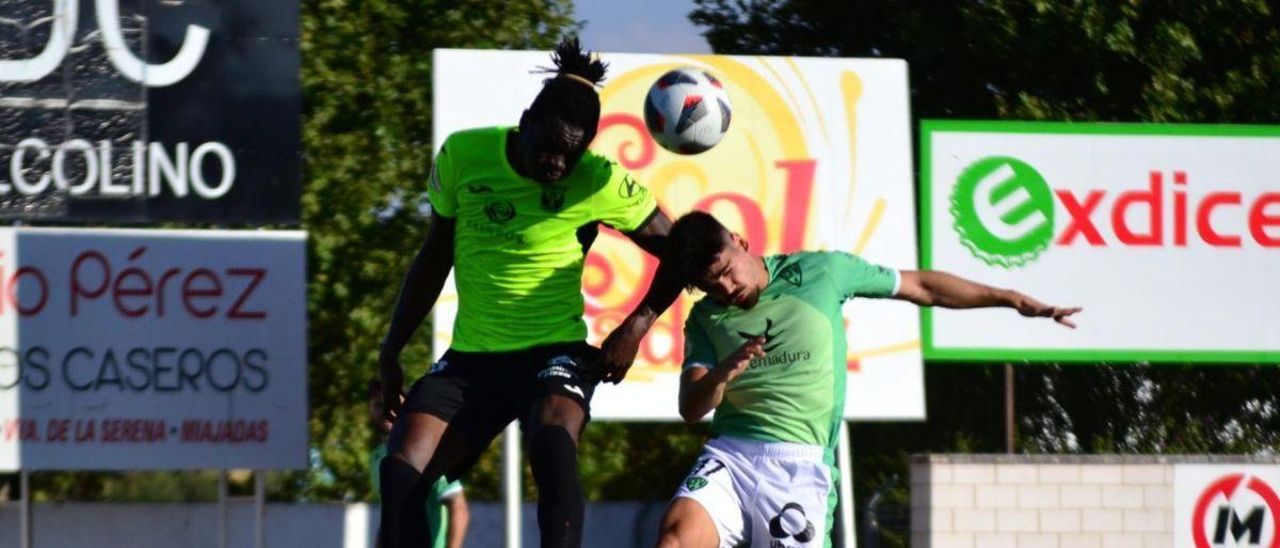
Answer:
[{"xmin": 435, "ymin": 50, "xmax": 924, "ymax": 420}]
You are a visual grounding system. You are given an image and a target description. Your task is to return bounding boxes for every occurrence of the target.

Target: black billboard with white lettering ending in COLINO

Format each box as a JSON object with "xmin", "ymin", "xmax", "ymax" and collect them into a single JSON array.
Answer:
[{"xmin": 0, "ymin": 0, "xmax": 302, "ymax": 224}]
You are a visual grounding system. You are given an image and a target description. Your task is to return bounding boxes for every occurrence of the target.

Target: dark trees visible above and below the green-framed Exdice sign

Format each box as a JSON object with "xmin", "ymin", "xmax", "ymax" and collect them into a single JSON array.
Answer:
[{"xmin": 690, "ymin": 0, "xmax": 1280, "ymax": 544}]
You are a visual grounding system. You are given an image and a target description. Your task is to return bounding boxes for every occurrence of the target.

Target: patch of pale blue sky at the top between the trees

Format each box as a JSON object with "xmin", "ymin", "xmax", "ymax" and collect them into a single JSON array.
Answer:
[{"xmin": 573, "ymin": 0, "xmax": 712, "ymax": 54}]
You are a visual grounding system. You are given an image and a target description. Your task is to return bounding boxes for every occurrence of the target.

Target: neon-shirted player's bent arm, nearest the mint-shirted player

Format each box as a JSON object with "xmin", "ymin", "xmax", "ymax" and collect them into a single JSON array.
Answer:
[{"xmin": 600, "ymin": 209, "xmax": 682, "ymax": 384}]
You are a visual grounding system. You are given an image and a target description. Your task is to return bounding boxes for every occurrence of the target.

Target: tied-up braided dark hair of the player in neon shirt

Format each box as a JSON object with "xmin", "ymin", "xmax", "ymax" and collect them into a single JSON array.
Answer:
[{"xmin": 529, "ymin": 37, "xmax": 608, "ymax": 142}]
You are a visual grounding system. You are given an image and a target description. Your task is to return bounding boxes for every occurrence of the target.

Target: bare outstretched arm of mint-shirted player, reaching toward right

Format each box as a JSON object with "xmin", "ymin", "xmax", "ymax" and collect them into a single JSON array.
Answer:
[{"xmin": 895, "ymin": 270, "xmax": 1084, "ymax": 329}]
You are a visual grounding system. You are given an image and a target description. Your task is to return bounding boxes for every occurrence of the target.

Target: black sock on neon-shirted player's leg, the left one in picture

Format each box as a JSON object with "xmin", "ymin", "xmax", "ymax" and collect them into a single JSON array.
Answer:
[{"xmin": 378, "ymin": 455, "xmax": 430, "ymax": 548}]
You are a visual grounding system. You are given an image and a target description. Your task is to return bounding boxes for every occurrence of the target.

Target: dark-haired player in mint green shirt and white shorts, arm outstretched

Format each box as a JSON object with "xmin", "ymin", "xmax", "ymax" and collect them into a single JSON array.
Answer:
[{"xmin": 658, "ymin": 213, "xmax": 1080, "ymax": 548}]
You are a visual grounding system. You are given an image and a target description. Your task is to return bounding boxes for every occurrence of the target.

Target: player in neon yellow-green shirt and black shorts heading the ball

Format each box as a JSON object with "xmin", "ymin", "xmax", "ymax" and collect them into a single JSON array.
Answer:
[{"xmin": 379, "ymin": 38, "xmax": 680, "ymax": 548}]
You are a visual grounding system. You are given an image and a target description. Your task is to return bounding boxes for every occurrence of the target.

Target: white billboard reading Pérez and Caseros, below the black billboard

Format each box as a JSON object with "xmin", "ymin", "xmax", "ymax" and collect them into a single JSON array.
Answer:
[{"xmin": 0, "ymin": 228, "xmax": 307, "ymax": 470}]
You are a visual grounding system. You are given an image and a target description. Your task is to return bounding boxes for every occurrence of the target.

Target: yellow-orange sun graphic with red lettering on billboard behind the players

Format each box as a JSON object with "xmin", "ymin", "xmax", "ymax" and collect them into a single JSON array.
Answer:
[{"xmin": 582, "ymin": 56, "xmax": 815, "ymax": 378}]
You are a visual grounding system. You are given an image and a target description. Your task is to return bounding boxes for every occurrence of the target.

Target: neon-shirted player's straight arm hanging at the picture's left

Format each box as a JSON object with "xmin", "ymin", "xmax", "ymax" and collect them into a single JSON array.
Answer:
[{"xmin": 378, "ymin": 213, "xmax": 456, "ymax": 420}]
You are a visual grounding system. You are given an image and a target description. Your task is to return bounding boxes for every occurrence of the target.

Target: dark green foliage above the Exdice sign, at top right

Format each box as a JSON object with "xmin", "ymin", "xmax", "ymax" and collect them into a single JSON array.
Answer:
[{"xmin": 690, "ymin": 0, "xmax": 1280, "ymax": 123}]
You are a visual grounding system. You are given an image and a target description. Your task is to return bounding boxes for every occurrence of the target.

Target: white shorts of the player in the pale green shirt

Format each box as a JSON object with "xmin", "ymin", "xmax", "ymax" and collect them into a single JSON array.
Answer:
[{"xmin": 675, "ymin": 437, "xmax": 833, "ymax": 548}]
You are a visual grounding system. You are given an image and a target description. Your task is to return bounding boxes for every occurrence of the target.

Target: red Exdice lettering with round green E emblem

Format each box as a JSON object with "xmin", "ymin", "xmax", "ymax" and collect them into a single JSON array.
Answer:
[{"xmin": 951, "ymin": 156, "xmax": 1280, "ymax": 268}]
